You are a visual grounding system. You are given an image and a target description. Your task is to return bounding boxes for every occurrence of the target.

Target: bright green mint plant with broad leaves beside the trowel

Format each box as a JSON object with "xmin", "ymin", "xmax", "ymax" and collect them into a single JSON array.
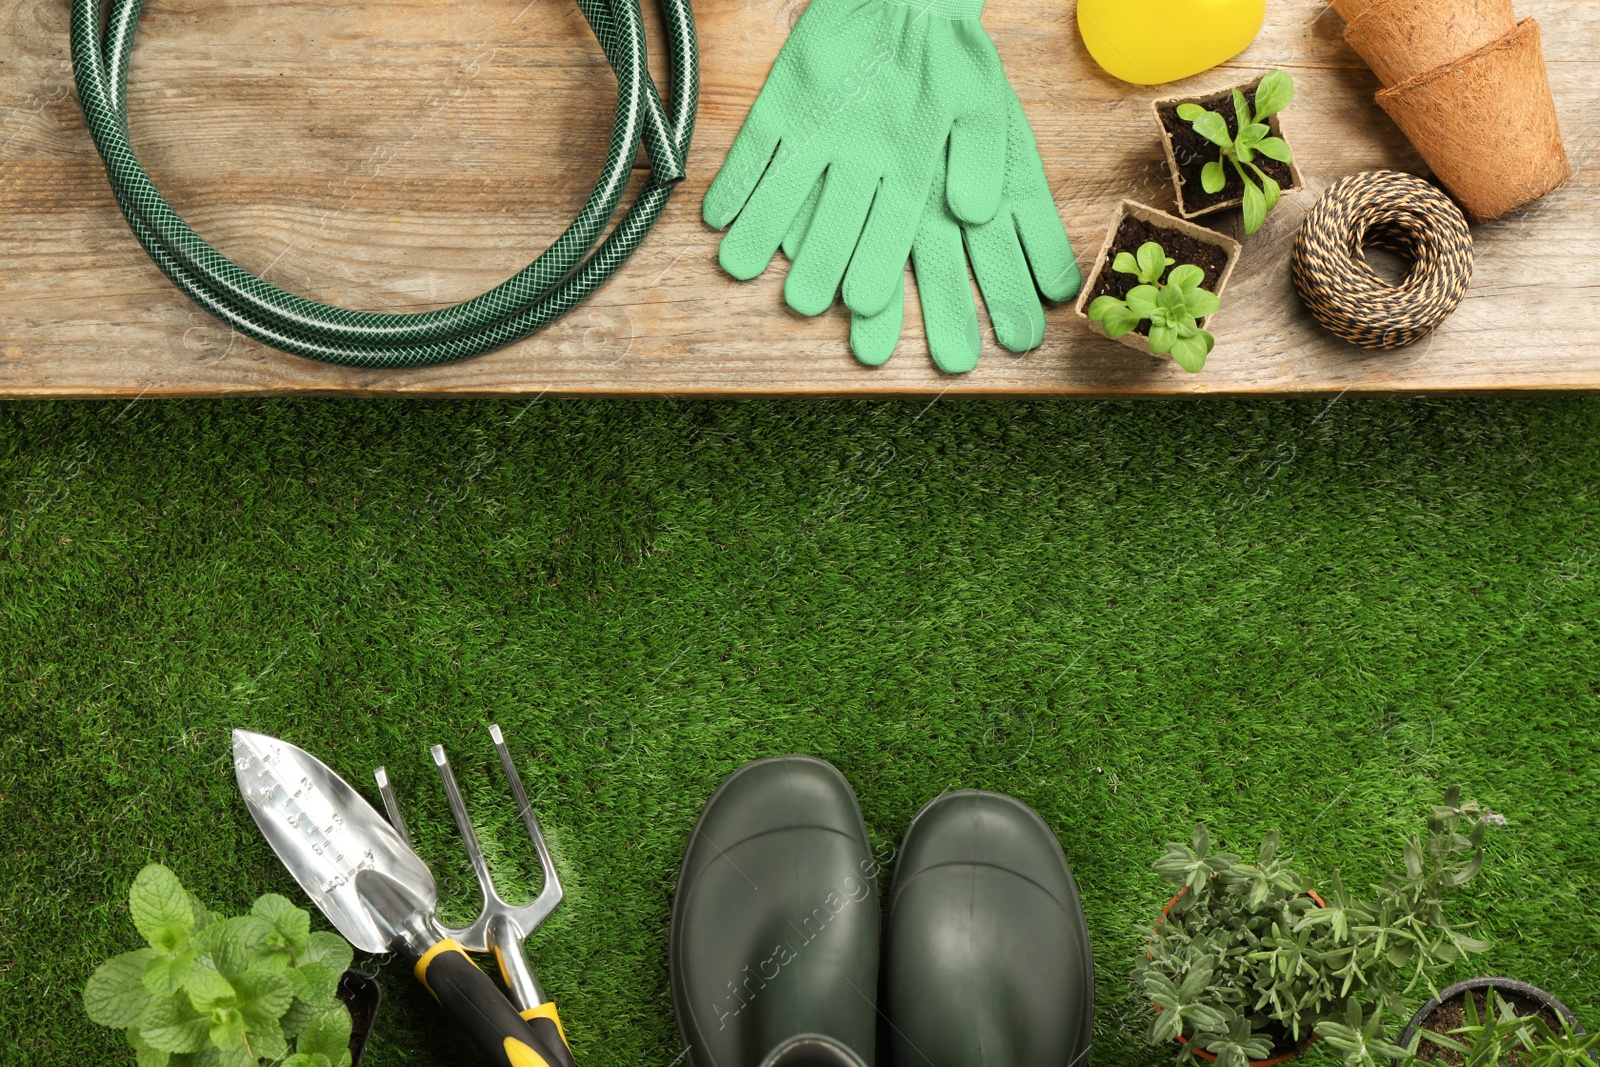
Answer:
[{"xmin": 83, "ymin": 864, "xmax": 354, "ymax": 1067}]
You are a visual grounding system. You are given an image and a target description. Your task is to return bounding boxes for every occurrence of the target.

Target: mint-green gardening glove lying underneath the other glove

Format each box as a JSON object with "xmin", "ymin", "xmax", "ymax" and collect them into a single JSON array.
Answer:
[{"xmin": 784, "ymin": 88, "xmax": 1083, "ymax": 374}]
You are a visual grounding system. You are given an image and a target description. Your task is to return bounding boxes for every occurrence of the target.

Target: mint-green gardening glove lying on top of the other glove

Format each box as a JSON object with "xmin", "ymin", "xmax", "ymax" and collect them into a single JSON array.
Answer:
[{"xmin": 704, "ymin": 0, "xmax": 1010, "ymax": 315}]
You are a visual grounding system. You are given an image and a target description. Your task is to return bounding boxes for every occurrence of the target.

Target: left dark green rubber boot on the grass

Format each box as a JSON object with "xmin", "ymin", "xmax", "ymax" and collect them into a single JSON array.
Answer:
[{"xmin": 669, "ymin": 757, "xmax": 878, "ymax": 1067}]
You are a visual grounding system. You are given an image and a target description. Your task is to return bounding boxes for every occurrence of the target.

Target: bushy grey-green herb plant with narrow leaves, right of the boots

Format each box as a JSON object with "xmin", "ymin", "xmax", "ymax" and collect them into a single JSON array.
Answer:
[{"xmin": 1134, "ymin": 789, "xmax": 1488, "ymax": 1067}]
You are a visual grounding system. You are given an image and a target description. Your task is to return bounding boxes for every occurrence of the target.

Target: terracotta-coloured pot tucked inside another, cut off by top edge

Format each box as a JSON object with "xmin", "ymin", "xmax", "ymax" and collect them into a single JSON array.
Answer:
[{"xmin": 1344, "ymin": 0, "xmax": 1517, "ymax": 86}]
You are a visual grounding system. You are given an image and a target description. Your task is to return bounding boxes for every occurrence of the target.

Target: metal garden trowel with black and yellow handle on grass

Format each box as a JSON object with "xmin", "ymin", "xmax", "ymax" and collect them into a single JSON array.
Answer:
[{"xmin": 234, "ymin": 729, "xmax": 571, "ymax": 1067}]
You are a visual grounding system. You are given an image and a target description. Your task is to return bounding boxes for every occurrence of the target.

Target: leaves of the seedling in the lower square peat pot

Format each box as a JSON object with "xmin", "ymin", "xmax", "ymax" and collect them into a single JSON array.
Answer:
[{"xmin": 1088, "ymin": 242, "xmax": 1222, "ymax": 374}]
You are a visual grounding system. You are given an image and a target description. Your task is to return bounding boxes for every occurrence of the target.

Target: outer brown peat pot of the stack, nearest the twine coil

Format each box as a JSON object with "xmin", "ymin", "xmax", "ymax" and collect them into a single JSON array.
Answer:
[{"xmin": 1378, "ymin": 19, "xmax": 1573, "ymax": 222}]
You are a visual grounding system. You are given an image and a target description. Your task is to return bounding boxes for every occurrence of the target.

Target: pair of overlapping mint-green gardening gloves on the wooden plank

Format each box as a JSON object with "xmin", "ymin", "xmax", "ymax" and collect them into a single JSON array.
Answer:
[{"xmin": 704, "ymin": 0, "xmax": 1082, "ymax": 374}]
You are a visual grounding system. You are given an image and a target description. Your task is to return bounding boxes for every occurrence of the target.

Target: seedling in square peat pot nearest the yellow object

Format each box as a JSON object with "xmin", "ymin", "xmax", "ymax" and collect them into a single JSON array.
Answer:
[{"xmin": 1155, "ymin": 70, "xmax": 1306, "ymax": 235}]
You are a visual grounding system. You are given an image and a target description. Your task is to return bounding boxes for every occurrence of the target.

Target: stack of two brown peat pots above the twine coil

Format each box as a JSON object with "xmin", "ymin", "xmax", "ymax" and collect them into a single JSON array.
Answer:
[{"xmin": 1334, "ymin": 0, "xmax": 1573, "ymax": 222}]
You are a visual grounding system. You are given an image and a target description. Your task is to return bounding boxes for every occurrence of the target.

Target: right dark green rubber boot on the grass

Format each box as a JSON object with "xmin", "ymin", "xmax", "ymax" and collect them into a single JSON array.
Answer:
[{"xmin": 883, "ymin": 792, "xmax": 1094, "ymax": 1067}]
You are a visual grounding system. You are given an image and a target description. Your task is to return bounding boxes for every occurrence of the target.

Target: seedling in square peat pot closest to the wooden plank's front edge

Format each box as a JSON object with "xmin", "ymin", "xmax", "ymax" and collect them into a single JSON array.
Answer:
[{"xmin": 1077, "ymin": 200, "xmax": 1240, "ymax": 373}]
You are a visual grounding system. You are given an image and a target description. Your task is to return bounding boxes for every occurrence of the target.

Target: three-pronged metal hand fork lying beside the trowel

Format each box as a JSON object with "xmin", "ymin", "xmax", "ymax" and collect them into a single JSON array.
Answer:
[{"xmin": 373, "ymin": 726, "xmax": 571, "ymax": 1067}]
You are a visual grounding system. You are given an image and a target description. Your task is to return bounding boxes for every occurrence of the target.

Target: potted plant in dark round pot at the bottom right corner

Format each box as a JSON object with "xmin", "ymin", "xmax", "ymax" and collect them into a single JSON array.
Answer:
[{"xmin": 1400, "ymin": 977, "xmax": 1600, "ymax": 1067}]
